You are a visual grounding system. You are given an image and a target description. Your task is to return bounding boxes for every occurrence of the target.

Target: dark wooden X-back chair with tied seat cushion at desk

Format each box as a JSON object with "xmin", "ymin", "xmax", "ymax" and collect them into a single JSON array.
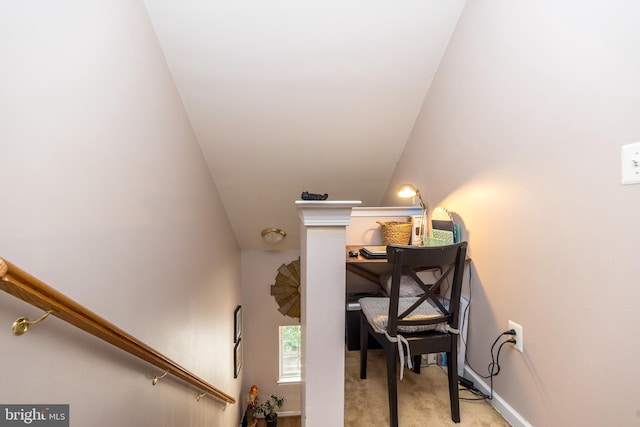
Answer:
[{"xmin": 359, "ymin": 242, "xmax": 467, "ymax": 427}]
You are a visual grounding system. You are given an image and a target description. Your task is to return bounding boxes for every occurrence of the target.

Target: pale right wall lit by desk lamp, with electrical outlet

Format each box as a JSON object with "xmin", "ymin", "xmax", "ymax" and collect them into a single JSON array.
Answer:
[{"xmin": 386, "ymin": 1, "xmax": 640, "ymax": 426}]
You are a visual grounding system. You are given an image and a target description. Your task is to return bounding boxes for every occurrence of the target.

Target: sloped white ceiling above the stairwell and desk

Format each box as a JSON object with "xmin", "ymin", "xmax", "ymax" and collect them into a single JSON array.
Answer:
[{"xmin": 144, "ymin": 0, "xmax": 464, "ymax": 250}]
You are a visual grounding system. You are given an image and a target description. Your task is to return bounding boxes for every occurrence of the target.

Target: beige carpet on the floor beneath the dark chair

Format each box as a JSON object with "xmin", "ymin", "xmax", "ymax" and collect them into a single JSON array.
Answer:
[{"xmin": 344, "ymin": 350, "xmax": 509, "ymax": 427}]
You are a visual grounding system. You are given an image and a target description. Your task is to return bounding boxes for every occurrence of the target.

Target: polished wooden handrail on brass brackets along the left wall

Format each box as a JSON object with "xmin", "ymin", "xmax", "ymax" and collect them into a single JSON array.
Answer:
[{"xmin": 0, "ymin": 258, "xmax": 236, "ymax": 403}]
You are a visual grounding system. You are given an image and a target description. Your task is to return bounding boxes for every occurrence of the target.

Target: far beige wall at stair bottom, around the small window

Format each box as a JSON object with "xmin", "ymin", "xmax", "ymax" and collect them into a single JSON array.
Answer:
[{"xmin": 241, "ymin": 251, "xmax": 301, "ymax": 412}]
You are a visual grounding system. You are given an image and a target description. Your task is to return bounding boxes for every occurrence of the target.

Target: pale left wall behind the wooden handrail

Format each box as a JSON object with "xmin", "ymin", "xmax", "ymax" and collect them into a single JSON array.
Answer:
[{"xmin": 0, "ymin": 0, "xmax": 241, "ymax": 427}]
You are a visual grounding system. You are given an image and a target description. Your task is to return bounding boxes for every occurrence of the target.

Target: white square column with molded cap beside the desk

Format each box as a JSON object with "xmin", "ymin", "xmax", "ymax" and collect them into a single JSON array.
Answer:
[{"xmin": 296, "ymin": 201, "xmax": 361, "ymax": 427}]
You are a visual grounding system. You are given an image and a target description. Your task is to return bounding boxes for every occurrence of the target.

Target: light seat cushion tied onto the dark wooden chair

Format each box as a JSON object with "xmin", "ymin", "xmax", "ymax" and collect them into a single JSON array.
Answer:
[{"xmin": 358, "ymin": 297, "xmax": 447, "ymax": 334}]
